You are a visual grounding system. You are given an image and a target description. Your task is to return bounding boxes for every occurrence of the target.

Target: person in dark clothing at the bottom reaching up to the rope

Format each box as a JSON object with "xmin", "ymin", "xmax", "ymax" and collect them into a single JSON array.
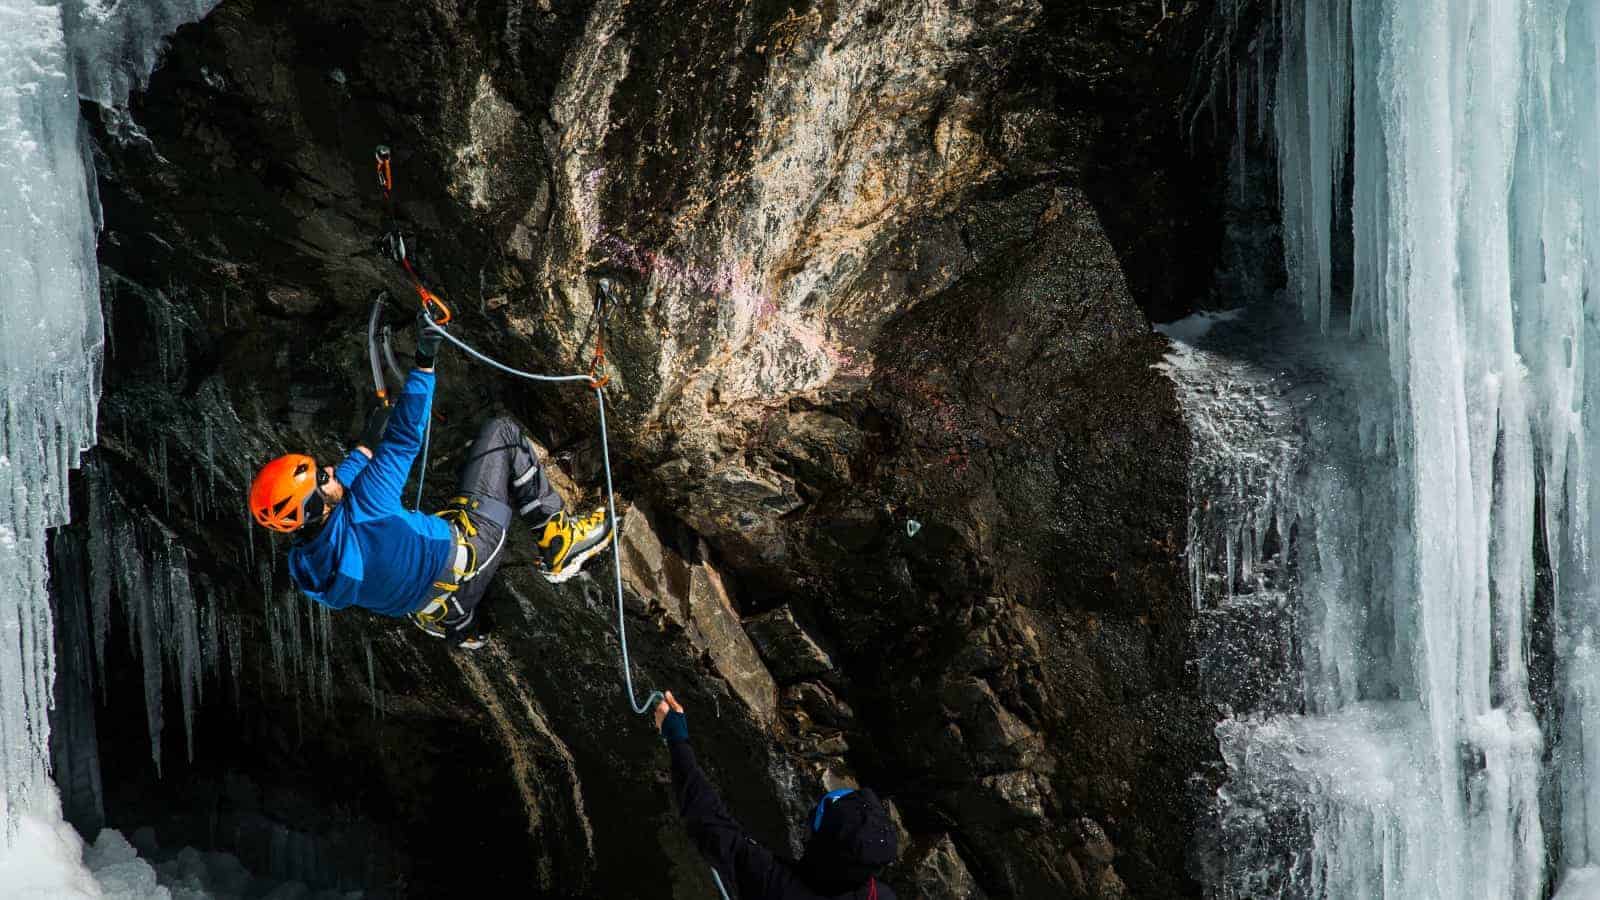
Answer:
[{"xmin": 656, "ymin": 692, "xmax": 898, "ymax": 900}]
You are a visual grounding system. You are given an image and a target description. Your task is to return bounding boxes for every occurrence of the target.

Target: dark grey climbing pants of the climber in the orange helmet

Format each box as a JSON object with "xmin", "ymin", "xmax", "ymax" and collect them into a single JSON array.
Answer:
[{"xmin": 438, "ymin": 416, "xmax": 562, "ymax": 613}]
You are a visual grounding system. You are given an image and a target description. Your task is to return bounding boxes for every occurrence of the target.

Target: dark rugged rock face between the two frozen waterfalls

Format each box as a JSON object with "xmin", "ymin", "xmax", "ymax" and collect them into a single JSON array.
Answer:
[{"xmin": 59, "ymin": 0, "xmax": 1214, "ymax": 898}]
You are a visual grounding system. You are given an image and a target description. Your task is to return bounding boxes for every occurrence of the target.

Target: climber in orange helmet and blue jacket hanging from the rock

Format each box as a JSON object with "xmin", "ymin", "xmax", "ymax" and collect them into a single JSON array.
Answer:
[{"xmin": 250, "ymin": 315, "xmax": 611, "ymax": 650}]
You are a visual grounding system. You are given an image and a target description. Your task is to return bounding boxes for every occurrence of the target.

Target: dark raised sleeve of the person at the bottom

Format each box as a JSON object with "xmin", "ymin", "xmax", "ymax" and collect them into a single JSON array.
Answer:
[{"xmin": 669, "ymin": 740, "xmax": 782, "ymax": 900}]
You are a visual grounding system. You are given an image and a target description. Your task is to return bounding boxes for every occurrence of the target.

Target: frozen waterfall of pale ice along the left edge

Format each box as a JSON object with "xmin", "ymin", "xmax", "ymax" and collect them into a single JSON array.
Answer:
[{"xmin": 0, "ymin": 0, "xmax": 214, "ymax": 897}]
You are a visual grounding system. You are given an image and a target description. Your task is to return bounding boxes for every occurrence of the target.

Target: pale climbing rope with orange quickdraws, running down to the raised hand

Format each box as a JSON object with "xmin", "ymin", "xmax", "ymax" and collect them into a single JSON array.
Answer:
[{"xmin": 376, "ymin": 146, "xmax": 659, "ymax": 714}]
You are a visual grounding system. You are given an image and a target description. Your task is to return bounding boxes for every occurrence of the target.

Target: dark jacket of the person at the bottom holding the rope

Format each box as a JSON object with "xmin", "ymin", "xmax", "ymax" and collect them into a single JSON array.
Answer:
[{"xmin": 667, "ymin": 740, "xmax": 896, "ymax": 900}]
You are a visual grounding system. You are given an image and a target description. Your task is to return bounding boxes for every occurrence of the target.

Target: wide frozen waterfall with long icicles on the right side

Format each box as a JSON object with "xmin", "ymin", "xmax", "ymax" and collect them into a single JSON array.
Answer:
[{"xmin": 1173, "ymin": 0, "xmax": 1600, "ymax": 900}]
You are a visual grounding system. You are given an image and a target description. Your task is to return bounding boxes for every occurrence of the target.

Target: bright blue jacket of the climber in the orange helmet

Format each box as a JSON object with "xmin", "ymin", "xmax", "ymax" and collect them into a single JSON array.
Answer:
[{"xmin": 290, "ymin": 370, "xmax": 454, "ymax": 618}]
